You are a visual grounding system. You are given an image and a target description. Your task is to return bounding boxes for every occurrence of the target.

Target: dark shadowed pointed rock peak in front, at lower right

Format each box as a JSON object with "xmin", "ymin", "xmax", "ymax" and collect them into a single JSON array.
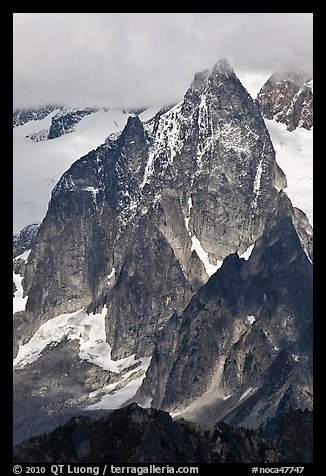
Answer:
[{"xmin": 138, "ymin": 192, "xmax": 312, "ymax": 428}]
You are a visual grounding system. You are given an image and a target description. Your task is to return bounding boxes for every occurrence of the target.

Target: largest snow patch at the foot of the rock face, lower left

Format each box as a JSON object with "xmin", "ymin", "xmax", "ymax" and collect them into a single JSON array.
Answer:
[{"xmin": 14, "ymin": 306, "xmax": 151, "ymax": 410}]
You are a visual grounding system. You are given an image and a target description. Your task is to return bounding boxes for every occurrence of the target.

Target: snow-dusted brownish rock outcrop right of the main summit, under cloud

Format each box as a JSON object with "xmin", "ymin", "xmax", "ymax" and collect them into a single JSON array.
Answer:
[{"xmin": 256, "ymin": 69, "xmax": 313, "ymax": 131}]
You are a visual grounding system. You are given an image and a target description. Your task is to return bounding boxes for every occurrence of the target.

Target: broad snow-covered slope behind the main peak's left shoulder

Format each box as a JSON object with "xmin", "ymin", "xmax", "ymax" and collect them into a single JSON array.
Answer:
[{"xmin": 13, "ymin": 108, "xmax": 158, "ymax": 234}]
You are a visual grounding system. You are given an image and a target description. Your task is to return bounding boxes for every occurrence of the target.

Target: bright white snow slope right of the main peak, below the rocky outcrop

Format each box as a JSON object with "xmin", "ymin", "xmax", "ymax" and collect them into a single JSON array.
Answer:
[{"xmin": 265, "ymin": 119, "xmax": 313, "ymax": 225}]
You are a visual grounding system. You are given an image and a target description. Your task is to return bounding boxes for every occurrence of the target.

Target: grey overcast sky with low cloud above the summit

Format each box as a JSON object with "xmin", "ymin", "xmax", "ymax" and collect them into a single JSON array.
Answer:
[{"xmin": 13, "ymin": 13, "xmax": 312, "ymax": 107}]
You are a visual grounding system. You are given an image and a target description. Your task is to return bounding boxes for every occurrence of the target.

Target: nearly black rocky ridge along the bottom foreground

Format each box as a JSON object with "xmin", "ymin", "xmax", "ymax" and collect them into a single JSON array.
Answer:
[{"xmin": 14, "ymin": 404, "xmax": 312, "ymax": 464}]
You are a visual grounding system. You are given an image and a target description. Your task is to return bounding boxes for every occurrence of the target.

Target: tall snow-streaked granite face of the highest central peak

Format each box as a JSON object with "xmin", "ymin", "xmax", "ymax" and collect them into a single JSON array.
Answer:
[{"xmin": 20, "ymin": 61, "xmax": 284, "ymax": 346}]
